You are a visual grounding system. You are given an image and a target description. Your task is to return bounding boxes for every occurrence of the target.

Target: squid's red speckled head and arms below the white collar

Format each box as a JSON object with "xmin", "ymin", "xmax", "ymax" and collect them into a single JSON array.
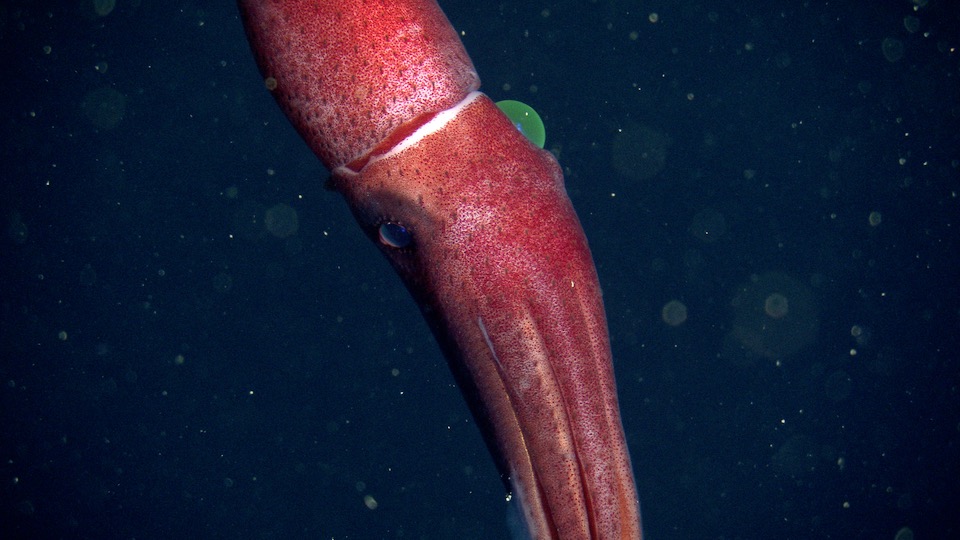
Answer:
[{"xmin": 334, "ymin": 94, "xmax": 640, "ymax": 539}]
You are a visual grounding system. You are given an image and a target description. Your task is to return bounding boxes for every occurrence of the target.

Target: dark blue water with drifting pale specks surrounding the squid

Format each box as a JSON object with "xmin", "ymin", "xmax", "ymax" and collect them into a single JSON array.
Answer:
[{"xmin": 0, "ymin": 0, "xmax": 960, "ymax": 540}]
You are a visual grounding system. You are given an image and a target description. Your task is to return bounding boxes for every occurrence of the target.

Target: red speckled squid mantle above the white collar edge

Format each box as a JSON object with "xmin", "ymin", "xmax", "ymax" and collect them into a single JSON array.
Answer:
[{"xmin": 240, "ymin": 0, "xmax": 480, "ymax": 170}]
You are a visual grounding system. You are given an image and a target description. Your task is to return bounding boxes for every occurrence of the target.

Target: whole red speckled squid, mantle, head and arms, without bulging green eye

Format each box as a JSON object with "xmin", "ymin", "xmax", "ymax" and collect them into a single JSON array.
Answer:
[{"xmin": 240, "ymin": 0, "xmax": 641, "ymax": 540}]
